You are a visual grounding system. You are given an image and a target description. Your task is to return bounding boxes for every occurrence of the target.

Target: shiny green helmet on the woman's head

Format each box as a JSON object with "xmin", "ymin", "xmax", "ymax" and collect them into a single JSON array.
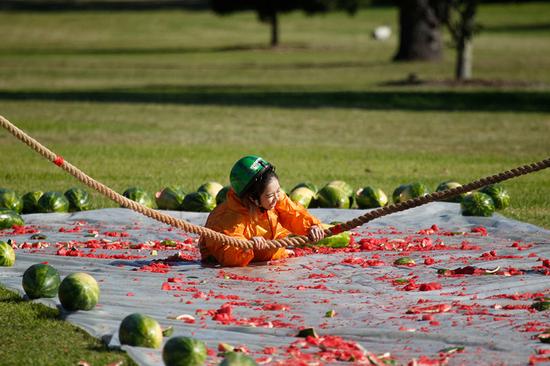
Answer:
[{"xmin": 229, "ymin": 155, "xmax": 273, "ymax": 197}]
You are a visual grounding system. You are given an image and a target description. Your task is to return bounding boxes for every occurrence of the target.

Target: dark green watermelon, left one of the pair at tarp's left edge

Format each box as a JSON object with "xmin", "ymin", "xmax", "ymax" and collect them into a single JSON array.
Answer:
[{"xmin": 23, "ymin": 264, "xmax": 61, "ymax": 299}]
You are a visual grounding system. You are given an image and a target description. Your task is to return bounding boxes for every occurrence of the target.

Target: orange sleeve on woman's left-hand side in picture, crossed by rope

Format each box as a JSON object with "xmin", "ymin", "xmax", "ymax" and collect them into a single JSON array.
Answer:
[{"xmin": 204, "ymin": 210, "xmax": 254, "ymax": 267}]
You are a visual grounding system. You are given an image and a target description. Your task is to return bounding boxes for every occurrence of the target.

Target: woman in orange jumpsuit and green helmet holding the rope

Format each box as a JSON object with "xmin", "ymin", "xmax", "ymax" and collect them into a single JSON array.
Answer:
[{"xmin": 199, "ymin": 155, "xmax": 325, "ymax": 267}]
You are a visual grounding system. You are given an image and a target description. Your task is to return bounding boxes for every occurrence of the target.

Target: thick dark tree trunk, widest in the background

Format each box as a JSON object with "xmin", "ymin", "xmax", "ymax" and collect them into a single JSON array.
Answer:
[{"xmin": 394, "ymin": 0, "xmax": 443, "ymax": 61}]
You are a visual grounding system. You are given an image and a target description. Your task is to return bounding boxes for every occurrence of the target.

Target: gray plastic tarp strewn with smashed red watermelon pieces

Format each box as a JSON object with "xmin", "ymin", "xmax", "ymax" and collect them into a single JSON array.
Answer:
[{"xmin": 0, "ymin": 203, "xmax": 550, "ymax": 365}]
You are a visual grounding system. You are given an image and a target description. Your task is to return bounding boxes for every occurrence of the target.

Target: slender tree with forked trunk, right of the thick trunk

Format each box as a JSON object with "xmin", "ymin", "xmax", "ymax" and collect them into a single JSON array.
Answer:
[{"xmin": 442, "ymin": 0, "xmax": 478, "ymax": 80}]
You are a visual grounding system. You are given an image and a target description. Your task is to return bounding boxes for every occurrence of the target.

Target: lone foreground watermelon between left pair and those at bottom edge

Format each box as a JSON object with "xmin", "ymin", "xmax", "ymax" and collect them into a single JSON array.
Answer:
[{"xmin": 118, "ymin": 313, "xmax": 162, "ymax": 348}]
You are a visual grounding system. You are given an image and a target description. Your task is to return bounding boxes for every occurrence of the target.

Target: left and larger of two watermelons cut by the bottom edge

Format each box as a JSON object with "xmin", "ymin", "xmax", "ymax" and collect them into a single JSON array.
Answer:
[{"xmin": 162, "ymin": 336, "xmax": 207, "ymax": 366}]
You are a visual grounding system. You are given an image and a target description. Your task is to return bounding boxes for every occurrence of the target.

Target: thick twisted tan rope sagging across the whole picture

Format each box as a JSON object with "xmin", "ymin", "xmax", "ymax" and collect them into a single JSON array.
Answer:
[{"xmin": 0, "ymin": 115, "xmax": 550, "ymax": 249}]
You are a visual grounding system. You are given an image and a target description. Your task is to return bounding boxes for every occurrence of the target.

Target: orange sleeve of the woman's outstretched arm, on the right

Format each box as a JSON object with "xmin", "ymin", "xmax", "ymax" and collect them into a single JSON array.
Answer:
[{"xmin": 275, "ymin": 193, "xmax": 321, "ymax": 235}]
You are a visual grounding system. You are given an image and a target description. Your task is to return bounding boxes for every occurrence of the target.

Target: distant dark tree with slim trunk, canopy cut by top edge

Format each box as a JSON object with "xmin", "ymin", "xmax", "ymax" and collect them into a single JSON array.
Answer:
[{"xmin": 210, "ymin": 0, "xmax": 359, "ymax": 47}]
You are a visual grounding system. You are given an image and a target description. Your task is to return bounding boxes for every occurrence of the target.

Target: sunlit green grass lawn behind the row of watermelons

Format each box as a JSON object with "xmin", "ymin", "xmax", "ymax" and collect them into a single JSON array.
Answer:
[{"xmin": 0, "ymin": 3, "xmax": 550, "ymax": 364}]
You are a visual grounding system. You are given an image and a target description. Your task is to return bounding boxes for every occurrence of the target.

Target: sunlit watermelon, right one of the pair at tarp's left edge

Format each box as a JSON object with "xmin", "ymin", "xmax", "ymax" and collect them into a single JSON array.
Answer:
[{"xmin": 58, "ymin": 272, "xmax": 99, "ymax": 311}]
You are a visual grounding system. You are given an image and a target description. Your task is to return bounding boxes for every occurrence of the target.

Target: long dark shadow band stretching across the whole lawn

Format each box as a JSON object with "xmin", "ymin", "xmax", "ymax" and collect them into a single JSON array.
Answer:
[{"xmin": 0, "ymin": 85, "xmax": 550, "ymax": 112}]
